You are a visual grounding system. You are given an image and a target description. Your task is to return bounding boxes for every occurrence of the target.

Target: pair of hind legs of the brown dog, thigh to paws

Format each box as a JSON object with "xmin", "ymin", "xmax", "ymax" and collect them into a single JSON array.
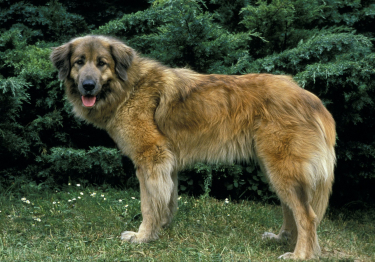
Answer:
[{"xmin": 256, "ymin": 126, "xmax": 320, "ymax": 259}]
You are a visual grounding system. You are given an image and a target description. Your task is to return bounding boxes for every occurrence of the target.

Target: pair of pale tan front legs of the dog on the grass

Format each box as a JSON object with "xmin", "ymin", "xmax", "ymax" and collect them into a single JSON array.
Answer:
[{"xmin": 121, "ymin": 148, "xmax": 177, "ymax": 243}]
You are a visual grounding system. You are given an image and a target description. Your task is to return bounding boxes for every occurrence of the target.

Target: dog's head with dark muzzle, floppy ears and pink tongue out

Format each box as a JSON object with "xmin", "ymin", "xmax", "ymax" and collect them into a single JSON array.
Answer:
[{"xmin": 50, "ymin": 36, "xmax": 135, "ymax": 108}]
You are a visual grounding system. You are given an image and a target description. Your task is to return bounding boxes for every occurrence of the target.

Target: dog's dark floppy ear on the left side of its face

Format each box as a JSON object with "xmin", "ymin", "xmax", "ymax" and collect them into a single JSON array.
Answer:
[{"xmin": 50, "ymin": 43, "xmax": 71, "ymax": 80}]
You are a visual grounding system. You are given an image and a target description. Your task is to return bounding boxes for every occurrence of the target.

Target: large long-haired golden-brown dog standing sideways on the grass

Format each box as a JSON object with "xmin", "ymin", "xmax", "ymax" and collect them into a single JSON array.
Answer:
[{"xmin": 51, "ymin": 36, "xmax": 336, "ymax": 259}]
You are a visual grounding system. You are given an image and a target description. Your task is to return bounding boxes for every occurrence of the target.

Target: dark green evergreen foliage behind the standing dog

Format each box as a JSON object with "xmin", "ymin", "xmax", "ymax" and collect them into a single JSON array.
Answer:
[{"xmin": 0, "ymin": 0, "xmax": 375, "ymax": 204}]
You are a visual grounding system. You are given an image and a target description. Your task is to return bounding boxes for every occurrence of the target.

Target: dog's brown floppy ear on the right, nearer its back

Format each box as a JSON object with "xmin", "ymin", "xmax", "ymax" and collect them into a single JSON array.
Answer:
[{"xmin": 111, "ymin": 41, "xmax": 135, "ymax": 81}]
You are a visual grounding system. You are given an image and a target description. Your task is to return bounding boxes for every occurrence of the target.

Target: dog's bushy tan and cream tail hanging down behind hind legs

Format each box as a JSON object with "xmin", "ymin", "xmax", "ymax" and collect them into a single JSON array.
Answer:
[{"xmin": 311, "ymin": 111, "xmax": 336, "ymax": 224}]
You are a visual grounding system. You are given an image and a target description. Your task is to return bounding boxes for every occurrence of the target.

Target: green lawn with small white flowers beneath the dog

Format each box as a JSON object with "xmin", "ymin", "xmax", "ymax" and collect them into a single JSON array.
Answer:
[{"xmin": 0, "ymin": 185, "xmax": 375, "ymax": 262}]
